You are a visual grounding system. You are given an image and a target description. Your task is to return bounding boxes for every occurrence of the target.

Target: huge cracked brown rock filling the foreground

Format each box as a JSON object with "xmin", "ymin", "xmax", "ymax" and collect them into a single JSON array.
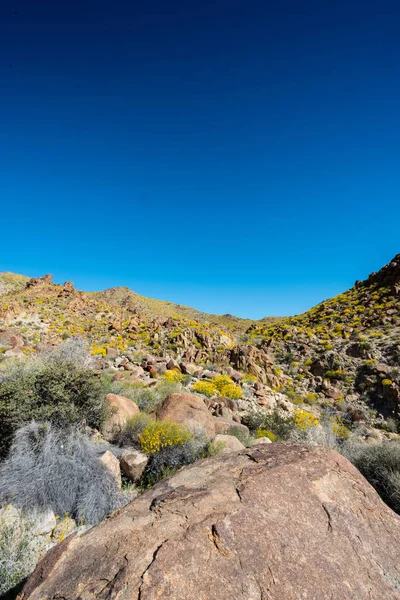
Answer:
[{"xmin": 19, "ymin": 444, "xmax": 400, "ymax": 600}]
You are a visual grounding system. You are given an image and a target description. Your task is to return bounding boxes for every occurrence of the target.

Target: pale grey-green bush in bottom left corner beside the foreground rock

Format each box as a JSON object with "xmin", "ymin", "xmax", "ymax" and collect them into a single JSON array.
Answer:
[{"xmin": 0, "ymin": 507, "xmax": 45, "ymax": 598}]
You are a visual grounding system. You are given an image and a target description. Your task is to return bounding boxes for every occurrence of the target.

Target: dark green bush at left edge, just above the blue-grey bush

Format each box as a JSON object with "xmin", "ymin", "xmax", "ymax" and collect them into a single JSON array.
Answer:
[{"xmin": 0, "ymin": 360, "xmax": 107, "ymax": 456}]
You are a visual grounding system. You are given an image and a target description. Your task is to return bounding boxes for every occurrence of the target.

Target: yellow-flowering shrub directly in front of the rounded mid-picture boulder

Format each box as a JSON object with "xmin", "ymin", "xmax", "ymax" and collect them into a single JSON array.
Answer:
[{"xmin": 139, "ymin": 421, "xmax": 192, "ymax": 454}]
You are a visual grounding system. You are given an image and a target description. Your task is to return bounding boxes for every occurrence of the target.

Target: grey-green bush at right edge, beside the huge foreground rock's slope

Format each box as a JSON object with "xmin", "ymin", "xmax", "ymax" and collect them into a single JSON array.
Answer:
[{"xmin": 345, "ymin": 441, "xmax": 400, "ymax": 514}]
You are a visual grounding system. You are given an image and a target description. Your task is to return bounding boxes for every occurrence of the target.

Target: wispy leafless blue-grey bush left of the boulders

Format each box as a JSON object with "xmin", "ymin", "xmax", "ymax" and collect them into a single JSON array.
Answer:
[{"xmin": 0, "ymin": 423, "xmax": 120, "ymax": 524}]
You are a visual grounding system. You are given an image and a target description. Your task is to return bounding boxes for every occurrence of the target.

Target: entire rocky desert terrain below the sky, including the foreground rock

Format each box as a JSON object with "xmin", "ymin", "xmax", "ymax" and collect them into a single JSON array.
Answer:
[{"xmin": 0, "ymin": 255, "xmax": 400, "ymax": 600}]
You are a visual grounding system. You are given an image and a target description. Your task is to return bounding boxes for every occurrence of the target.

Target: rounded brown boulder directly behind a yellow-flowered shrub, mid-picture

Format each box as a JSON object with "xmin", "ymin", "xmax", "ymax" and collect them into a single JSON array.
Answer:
[{"xmin": 155, "ymin": 393, "xmax": 215, "ymax": 437}]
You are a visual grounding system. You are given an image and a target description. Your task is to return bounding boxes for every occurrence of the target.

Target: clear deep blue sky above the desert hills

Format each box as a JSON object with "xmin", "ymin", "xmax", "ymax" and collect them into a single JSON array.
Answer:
[{"xmin": 0, "ymin": 0, "xmax": 400, "ymax": 318}]
